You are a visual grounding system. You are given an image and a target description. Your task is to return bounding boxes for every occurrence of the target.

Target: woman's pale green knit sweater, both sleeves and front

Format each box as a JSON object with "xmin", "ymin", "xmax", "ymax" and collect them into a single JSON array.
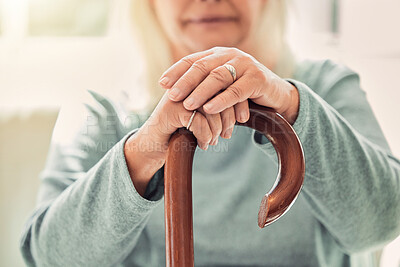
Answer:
[{"xmin": 21, "ymin": 60, "xmax": 400, "ymax": 267}]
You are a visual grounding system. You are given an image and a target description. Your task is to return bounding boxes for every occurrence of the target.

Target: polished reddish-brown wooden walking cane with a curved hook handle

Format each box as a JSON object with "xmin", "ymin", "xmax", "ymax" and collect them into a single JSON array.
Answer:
[{"xmin": 164, "ymin": 100, "xmax": 305, "ymax": 267}]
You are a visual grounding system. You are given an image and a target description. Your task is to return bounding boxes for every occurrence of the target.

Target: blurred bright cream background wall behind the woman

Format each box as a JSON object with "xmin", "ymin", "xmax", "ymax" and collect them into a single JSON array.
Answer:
[{"xmin": 0, "ymin": 0, "xmax": 400, "ymax": 267}]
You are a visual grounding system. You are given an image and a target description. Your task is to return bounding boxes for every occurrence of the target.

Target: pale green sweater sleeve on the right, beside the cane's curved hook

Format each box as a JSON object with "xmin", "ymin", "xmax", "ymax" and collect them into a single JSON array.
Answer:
[{"xmin": 253, "ymin": 60, "xmax": 400, "ymax": 254}]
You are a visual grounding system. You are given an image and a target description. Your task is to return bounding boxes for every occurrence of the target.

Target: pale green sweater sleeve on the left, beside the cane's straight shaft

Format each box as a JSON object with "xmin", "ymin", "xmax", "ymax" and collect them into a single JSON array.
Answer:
[{"xmin": 20, "ymin": 92, "xmax": 162, "ymax": 266}]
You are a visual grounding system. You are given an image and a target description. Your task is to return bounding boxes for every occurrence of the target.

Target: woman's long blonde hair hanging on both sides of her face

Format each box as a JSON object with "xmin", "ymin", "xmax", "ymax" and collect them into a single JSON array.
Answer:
[{"xmin": 131, "ymin": 0, "xmax": 294, "ymax": 112}]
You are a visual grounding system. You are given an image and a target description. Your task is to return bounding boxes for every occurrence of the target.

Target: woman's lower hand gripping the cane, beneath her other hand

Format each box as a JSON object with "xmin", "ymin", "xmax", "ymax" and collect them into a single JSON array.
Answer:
[{"xmin": 124, "ymin": 92, "xmax": 228, "ymax": 196}]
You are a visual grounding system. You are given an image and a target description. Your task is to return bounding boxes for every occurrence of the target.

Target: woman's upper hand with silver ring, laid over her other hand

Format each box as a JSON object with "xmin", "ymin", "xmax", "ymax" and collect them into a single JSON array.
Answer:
[{"xmin": 160, "ymin": 47, "xmax": 299, "ymax": 126}]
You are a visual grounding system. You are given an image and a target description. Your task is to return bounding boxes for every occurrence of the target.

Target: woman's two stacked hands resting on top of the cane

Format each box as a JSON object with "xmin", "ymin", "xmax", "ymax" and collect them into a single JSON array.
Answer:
[{"xmin": 124, "ymin": 47, "xmax": 299, "ymax": 195}]
